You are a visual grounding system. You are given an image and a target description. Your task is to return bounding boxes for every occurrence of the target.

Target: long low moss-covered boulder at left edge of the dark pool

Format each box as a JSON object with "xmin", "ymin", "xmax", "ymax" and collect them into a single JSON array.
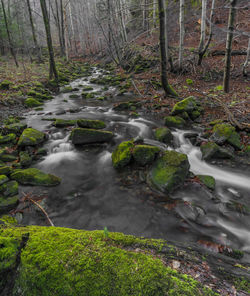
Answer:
[{"xmin": 10, "ymin": 168, "xmax": 61, "ymax": 186}]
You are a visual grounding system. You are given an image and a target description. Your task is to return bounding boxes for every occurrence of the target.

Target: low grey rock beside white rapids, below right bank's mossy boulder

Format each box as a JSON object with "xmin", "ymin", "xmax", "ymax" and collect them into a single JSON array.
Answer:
[{"xmin": 200, "ymin": 142, "xmax": 233, "ymax": 160}]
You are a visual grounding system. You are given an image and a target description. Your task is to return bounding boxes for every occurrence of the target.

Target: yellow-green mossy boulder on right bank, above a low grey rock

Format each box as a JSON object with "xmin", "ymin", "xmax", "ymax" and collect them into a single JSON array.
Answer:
[{"xmin": 210, "ymin": 123, "xmax": 242, "ymax": 149}]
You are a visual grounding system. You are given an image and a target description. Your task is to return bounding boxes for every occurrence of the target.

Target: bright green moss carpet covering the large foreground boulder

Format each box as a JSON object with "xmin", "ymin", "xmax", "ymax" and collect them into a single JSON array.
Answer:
[{"xmin": 0, "ymin": 226, "xmax": 215, "ymax": 296}]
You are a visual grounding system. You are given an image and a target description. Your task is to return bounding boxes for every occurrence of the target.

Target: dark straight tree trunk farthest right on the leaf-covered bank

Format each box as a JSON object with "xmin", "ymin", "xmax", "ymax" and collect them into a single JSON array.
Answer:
[{"xmin": 223, "ymin": 0, "xmax": 237, "ymax": 93}]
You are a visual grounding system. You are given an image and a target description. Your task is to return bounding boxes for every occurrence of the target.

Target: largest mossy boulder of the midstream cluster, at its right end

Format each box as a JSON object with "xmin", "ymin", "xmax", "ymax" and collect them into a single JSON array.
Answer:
[{"xmin": 147, "ymin": 151, "xmax": 190, "ymax": 193}]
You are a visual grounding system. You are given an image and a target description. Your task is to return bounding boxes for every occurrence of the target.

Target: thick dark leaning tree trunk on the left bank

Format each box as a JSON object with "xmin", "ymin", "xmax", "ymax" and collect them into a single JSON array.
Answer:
[{"xmin": 40, "ymin": 0, "xmax": 58, "ymax": 81}]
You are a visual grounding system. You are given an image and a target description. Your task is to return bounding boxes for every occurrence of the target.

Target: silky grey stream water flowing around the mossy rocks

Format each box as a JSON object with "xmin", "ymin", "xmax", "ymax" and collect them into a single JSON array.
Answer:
[{"xmin": 18, "ymin": 70, "xmax": 250, "ymax": 260}]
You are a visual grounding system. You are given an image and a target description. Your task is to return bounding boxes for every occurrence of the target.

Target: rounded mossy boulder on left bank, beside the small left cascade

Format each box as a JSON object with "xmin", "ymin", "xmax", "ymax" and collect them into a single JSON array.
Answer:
[{"xmin": 18, "ymin": 128, "xmax": 45, "ymax": 147}]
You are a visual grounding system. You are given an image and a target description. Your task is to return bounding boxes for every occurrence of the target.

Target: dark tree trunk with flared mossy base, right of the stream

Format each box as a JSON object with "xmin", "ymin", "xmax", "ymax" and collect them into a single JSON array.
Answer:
[{"xmin": 158, "ymin": 0, "xmax": 177, "ymax": 96}]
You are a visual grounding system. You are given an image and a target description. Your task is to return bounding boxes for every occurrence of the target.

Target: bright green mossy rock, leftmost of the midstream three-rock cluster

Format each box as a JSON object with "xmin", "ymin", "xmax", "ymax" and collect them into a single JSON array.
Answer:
[{"xmin": 112, "ymin": 141, "xmax": 134, "ymax": 169}]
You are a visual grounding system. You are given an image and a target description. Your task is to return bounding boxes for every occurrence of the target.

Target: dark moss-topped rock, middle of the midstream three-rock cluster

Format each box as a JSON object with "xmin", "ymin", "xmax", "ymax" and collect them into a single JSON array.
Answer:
[{"xmin": 133, "ymin": 145, "xmax": 160, "ymax": 165}]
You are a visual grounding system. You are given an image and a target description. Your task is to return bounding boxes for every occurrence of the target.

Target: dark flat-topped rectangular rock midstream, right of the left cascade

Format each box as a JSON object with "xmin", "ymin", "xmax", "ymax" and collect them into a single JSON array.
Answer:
[{"xmin": 71, "ymin": 128, "xmax": 114, "ymax": 145}]
